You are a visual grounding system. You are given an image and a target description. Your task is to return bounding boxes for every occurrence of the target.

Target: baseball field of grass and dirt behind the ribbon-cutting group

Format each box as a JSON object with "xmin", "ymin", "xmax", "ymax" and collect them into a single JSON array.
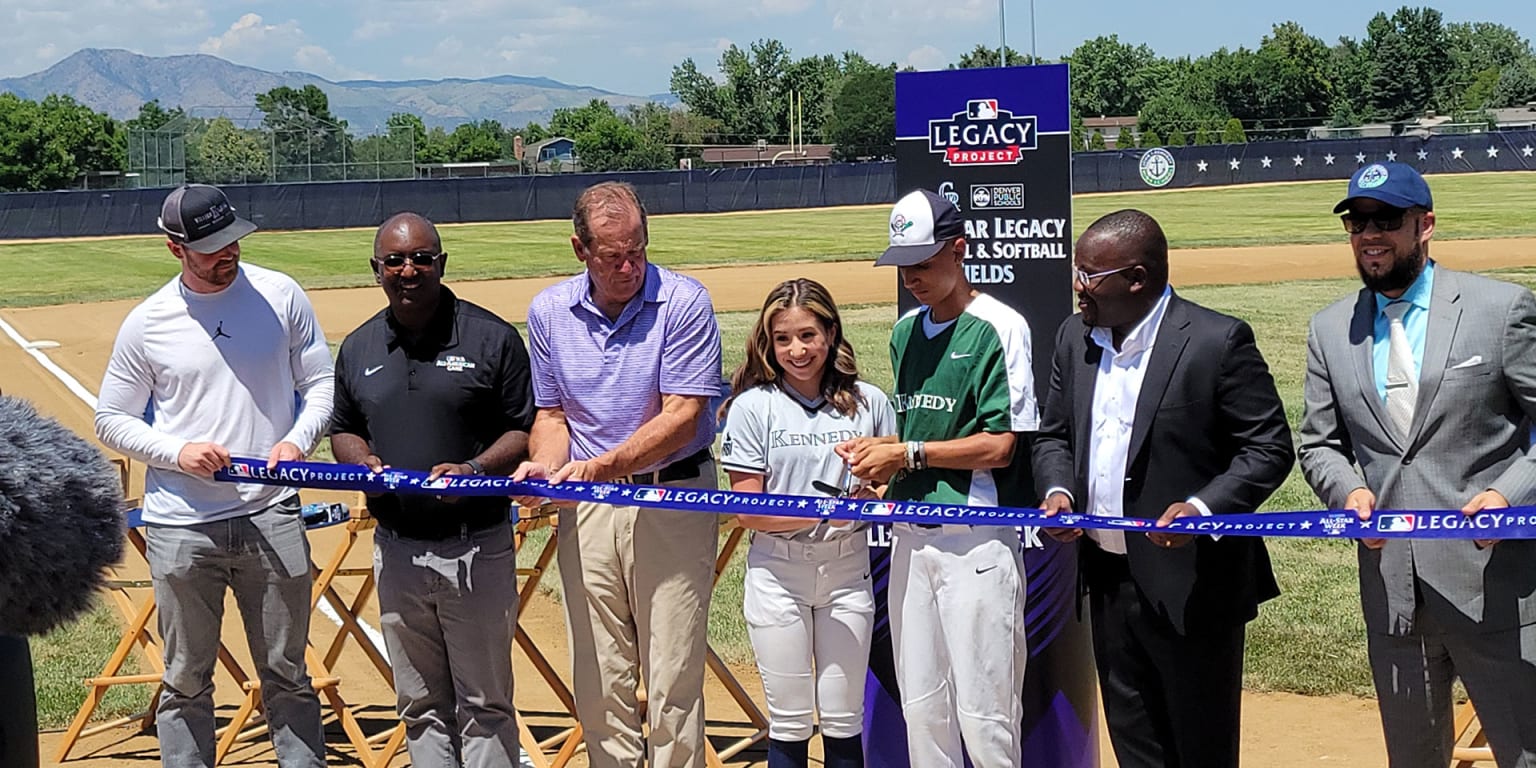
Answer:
[{"xmin": 9, "ymin": 174, "xmax": 1536, "ymax": 766}]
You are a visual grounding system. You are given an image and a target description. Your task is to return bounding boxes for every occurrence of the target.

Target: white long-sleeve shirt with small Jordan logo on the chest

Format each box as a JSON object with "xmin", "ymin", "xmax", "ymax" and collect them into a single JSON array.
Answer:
[{"xmin": 95, "ymin": 264, "xmax": 335, "ymax": 525}]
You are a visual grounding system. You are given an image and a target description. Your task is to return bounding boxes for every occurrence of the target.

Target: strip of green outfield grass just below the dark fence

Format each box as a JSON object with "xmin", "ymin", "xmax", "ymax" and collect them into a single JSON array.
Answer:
[{"xmin": 9, "ymin": 174, "xmax": 1536, "ymax": 307}]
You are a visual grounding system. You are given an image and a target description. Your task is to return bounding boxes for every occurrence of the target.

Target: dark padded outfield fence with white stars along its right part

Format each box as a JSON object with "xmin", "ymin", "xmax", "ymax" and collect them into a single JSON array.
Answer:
[{"xmin": 0, "ymin": 131, "xmax": 1536, "ymax": 240}]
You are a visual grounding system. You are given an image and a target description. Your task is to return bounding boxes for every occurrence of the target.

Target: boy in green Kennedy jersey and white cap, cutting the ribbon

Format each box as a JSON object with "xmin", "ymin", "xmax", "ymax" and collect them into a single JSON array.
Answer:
[{"xmin": 839, "ymin": 190, "xmax": 1038, "ymax": 768}]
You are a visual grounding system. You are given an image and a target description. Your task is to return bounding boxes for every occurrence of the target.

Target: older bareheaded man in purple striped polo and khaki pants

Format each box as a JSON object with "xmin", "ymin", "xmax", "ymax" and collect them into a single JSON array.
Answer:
[{"xmin": 515, "ymin": 181, "xmax": 720, "ymax": 768}]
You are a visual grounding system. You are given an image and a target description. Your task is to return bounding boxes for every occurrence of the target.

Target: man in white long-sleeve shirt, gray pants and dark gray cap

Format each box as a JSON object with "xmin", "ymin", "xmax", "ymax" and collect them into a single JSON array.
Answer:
[{"xmin": 95, "ymin": 184, "xmax": 335, "ymax": 768}]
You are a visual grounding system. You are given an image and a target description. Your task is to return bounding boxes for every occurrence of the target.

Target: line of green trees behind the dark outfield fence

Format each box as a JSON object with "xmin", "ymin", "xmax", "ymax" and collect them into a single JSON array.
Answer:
[{"xmin": 0, "ymin": 6, "xmax": 1536, "ymax": 190}]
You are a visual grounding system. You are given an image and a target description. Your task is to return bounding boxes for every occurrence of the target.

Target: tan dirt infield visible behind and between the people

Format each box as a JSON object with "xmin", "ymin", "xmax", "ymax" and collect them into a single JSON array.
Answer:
[{"xmin": 18, "ymin": 240, "xmax": 1536, "ymax": 768}]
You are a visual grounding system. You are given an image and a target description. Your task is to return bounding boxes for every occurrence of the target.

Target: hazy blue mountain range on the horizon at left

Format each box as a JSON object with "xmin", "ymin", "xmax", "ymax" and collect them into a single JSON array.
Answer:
[{"xmin": 0, "ymin": 48, "xmax": 677, "ymax": 134}]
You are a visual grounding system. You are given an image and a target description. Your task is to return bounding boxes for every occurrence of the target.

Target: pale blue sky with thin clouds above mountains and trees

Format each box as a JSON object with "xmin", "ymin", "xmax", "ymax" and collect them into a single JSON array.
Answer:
[{"xmin": 0, "ymin": 0, "xmax": 1536, "ymax": 94}]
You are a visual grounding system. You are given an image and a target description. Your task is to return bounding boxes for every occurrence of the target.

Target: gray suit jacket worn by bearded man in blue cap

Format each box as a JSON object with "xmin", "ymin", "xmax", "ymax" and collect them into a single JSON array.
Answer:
[{"xmin": 1299, "ymin": 266, "xmax": 1536, "ymax": 634}]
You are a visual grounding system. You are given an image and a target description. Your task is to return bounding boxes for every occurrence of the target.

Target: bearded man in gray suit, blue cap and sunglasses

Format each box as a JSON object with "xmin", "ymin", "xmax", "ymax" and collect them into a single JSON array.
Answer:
[{"xmin": 1299, "ymin": 163, "xmax": 1536, "ymax": 768}]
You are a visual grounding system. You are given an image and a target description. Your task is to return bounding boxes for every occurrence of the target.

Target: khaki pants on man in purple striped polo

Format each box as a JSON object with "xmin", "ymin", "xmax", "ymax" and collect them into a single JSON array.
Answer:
[{"xmin": 559, "ymin": 461, "xmax": 719, "ymax": 768}]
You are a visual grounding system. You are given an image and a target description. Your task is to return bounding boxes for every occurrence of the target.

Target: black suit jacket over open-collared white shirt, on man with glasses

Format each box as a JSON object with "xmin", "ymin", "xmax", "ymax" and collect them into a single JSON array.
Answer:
[{"xmin": 1034, "ymin": 295, "xmax": 1295, "ymax": 633}]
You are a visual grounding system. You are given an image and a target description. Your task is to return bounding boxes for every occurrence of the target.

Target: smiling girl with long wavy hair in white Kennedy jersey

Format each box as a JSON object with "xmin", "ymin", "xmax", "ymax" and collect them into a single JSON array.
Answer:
[{"xmin": 720, "ymin": 280, "xmax": 895, "ymax": 768}]
